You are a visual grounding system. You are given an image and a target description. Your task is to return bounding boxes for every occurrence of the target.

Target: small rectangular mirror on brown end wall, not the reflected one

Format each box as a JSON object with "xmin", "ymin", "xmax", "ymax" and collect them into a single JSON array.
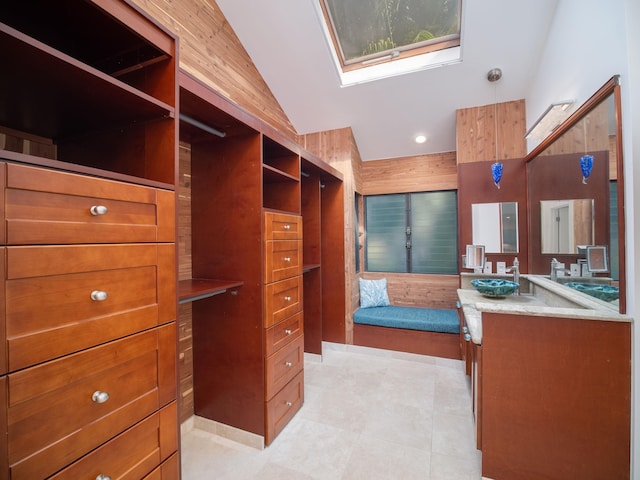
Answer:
[{"xmin": 471, "ymin": 202, "xmax": 518, "ymax": 253}]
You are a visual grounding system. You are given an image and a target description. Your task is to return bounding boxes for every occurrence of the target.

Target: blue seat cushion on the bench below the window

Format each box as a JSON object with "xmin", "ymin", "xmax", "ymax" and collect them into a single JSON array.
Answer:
[{"xmin": 353, "ymin": 305, "xmax": 460, "ymax": 333}]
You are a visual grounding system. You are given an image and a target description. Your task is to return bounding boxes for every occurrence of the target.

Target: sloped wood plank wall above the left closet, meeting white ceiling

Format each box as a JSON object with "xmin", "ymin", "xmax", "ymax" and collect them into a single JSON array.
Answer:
[{"xmin": 131, "ymin": 0, "xmax": 298, "ymax": 141}]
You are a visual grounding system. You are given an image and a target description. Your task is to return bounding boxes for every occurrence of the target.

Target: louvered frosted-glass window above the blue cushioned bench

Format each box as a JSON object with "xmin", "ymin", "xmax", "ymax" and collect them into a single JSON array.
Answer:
[{"xmin": 365, "ymin": 190, "xmax": 458, "ymax": 274}]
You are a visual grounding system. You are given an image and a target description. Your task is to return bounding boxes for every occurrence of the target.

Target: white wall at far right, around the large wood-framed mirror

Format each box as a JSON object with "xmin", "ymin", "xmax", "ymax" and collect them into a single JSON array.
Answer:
[{"xmin": 526, "ymin": 0, "xmax": 640, "ymax": 479}]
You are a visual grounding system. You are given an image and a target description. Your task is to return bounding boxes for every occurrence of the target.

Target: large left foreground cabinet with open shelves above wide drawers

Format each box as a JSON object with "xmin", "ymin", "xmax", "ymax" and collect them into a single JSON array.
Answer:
[{"xmin": 0, "ymin": 0, "xmax": 180, "ymax": 480}]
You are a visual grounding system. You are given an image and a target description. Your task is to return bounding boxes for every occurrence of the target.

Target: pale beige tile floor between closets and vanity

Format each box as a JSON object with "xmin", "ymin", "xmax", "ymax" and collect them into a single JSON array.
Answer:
[{"xmin": 182, "ymin": 344, "xmax": 481, "ymax": 480}]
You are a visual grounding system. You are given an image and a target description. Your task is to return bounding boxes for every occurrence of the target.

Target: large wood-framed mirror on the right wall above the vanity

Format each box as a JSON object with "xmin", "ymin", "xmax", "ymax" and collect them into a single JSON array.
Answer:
[{"xmin": 526, "ymin": 76, "xmax": 626, "ymax": 313}]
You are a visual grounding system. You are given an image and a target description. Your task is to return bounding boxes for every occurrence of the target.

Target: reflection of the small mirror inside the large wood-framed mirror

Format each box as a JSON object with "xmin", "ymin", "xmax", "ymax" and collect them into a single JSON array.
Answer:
[{"xmin": 540, "ymin": 198, "xmax": 594, "ymax": 254}]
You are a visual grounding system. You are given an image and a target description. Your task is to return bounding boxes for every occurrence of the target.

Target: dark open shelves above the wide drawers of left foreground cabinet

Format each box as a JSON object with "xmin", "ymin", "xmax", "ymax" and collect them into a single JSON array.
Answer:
[{"xmin": 0, "ymin": 0, "xmax": 177, "ymax": 185}]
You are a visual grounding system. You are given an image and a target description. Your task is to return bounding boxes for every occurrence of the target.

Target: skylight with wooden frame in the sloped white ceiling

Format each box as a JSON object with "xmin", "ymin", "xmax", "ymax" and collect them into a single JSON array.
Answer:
[{"xmin": 318, "ymin": 0, "xmax": 461, "ymax": 84}]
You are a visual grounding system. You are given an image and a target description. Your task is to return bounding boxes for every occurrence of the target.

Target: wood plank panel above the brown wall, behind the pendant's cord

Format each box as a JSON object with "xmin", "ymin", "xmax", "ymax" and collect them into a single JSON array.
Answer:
[{"xmin": 456, "ymin": 100, "xmax": 527, "ymax": 163}]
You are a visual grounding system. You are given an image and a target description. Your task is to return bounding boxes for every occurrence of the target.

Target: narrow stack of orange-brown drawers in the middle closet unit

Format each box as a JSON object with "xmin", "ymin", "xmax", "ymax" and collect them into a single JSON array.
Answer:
[{"xmin": 263, "ymin": 212, "xmax": 304, "ymax": 445}]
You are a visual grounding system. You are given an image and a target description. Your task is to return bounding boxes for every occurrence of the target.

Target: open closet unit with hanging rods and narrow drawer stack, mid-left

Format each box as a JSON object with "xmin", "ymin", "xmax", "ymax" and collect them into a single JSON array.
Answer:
[{"xmin": 180, "ymin": 72, "xmax": 344, "ymax": 445}]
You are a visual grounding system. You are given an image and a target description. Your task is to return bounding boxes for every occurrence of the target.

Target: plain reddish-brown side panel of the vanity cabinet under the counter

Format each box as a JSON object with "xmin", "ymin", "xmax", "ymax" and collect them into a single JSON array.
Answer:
[{"xmin": 482, "ymin": 312, "xmax": 631, "ymax": 480}]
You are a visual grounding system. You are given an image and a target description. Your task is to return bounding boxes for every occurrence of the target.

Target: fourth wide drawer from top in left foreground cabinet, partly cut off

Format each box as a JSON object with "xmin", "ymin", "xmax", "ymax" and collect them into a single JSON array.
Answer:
[{"xmin": 51, "ymin": 403, "xmax": 178, "ymax": 480}]
